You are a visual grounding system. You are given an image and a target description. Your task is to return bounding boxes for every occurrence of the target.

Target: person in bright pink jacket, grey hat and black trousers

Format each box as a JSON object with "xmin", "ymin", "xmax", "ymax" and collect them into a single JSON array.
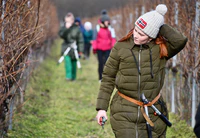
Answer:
[{"xmin": 92, "ymin": 10, "xmax": 115, "ymax": 82}]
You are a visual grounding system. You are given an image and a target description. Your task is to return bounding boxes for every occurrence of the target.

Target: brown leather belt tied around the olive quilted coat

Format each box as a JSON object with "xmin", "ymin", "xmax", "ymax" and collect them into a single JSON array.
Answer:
[{"xmin": 118, "ymin": 91, "xmax": 160, "ymax": 127}]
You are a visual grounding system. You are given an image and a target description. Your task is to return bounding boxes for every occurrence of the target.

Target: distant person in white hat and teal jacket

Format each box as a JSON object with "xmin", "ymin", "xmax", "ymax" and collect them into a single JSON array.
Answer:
[{"xmin": 83, "ymin": 22, "xmax": 93, "ymax": 59}]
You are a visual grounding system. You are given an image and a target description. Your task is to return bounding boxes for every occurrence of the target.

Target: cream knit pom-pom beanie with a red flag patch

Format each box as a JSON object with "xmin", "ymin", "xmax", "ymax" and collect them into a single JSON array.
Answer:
[{"xmin": 135, "ymin": 4, "xmax": 167, "ymax": 38}]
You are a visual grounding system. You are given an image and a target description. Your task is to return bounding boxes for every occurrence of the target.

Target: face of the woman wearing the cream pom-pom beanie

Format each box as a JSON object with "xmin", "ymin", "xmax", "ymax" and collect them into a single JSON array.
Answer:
[{"xmin": 133, "ymin": 27, "xmax": 152, "ymax": 45}]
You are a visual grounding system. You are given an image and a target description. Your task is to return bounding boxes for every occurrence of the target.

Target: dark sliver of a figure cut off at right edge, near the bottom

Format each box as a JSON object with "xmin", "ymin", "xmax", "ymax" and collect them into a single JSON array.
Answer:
[{"xmin": 194, "ymin": 104, "xmax": 200, "ymax": 138}]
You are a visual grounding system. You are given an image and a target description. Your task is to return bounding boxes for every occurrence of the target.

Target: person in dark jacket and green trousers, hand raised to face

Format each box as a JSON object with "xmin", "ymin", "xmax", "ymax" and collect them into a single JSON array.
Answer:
[{"xmin": 59, "ymin": 12, "xmax": 84, "ymax": 81}]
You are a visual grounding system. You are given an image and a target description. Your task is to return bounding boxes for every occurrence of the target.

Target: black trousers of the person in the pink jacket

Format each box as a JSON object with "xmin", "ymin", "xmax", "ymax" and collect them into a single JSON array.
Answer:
[{"xmin": 97, "ymin": 50, "xmax": 110, "ymax": 80}]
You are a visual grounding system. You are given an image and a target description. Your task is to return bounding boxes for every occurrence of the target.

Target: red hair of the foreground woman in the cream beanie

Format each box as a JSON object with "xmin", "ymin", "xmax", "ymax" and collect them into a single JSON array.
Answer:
[{"xmin": 119, "ymin": 28, "xmax": 168, "ymax": 58}]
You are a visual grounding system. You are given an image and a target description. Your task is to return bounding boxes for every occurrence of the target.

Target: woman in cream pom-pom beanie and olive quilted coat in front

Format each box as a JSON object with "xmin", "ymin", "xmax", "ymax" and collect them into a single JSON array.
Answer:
[{"xmin": 96, "ymin": 4, "xmax": 187, "ymax": 138}]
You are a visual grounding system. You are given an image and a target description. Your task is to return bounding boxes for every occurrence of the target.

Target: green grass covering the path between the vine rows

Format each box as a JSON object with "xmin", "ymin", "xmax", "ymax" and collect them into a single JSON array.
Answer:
[{"xmin": 8, "ymin": 40, "xmax": 194, "ymax": 138}]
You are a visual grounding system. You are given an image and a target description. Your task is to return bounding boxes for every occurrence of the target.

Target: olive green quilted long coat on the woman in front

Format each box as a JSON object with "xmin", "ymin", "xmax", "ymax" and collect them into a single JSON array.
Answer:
[{"xmin": 96, "ymin": 25, "xmax": 187, "ymax": 138}]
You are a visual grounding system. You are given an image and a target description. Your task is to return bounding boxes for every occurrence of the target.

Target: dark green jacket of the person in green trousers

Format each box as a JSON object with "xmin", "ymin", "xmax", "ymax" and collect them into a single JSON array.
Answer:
[{"xmin": 58, "ymin": 24, "xmax": 84, "ymax": 60}]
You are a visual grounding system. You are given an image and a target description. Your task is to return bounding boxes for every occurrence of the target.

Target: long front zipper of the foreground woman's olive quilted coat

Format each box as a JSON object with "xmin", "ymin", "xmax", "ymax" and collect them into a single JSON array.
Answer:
[{"xmin": 135, "ymin": 45, "xmax": 142, "ymax": 138}]
